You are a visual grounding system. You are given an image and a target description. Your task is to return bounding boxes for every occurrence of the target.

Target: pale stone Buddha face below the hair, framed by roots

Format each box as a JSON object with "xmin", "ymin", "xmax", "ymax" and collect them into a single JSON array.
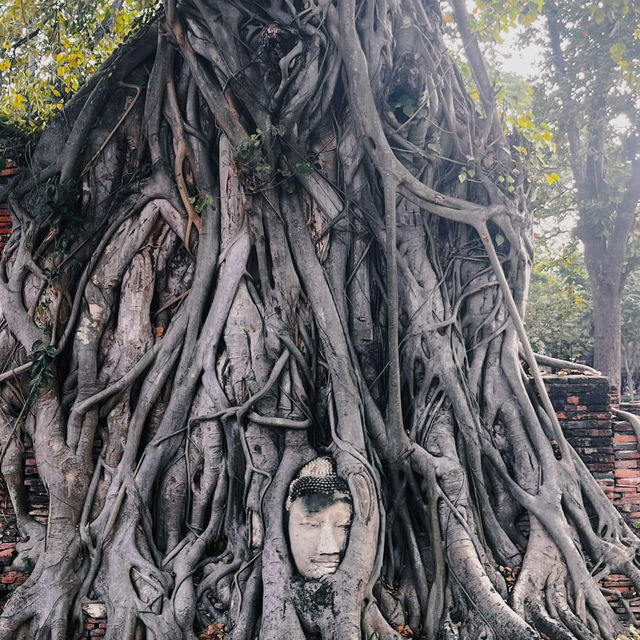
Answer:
[{"xmin": 289, "ymin": 493, "xmax": 352, "ymax": 580}]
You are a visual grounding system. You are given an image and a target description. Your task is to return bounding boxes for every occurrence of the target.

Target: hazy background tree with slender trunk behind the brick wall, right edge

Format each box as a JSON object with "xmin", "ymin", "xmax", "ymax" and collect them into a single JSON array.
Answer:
[{"xmin": 543, "ymin": 0, "xmax": 640, "ymax": 387}]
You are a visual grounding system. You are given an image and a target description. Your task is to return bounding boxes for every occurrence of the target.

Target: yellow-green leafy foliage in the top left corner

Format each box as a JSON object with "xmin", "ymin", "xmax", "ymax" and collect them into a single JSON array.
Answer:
[{"xmin": 0, "ymin": 0, "xmax": 160, "ymax": 131}]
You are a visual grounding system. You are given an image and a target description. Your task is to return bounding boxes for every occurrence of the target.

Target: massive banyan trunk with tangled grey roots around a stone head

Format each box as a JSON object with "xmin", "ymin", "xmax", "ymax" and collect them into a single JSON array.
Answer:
[{"xmin": 0, "ymin": 0, "xmax": 640, "ymax": 640}]
